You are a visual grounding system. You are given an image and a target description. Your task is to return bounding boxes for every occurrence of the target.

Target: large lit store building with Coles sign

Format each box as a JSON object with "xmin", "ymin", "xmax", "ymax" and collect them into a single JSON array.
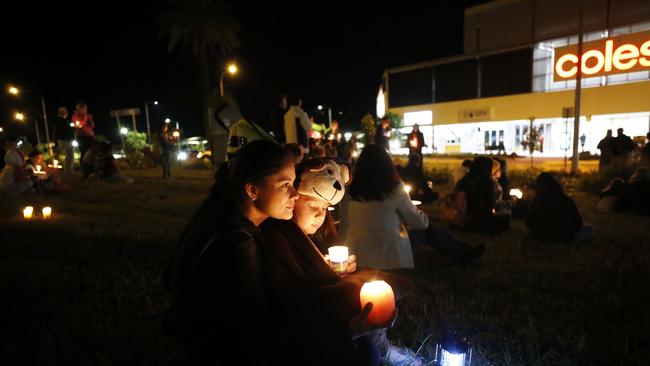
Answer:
[{"xmin": 377, "ymin": 0, "xmax": 650, "ymax": 156}]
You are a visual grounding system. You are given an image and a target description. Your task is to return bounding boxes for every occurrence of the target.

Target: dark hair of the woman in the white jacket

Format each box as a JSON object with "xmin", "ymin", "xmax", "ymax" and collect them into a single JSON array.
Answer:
[{"xmin": 350, "ymin": 145, "xmax": 399, "ymax": 201}]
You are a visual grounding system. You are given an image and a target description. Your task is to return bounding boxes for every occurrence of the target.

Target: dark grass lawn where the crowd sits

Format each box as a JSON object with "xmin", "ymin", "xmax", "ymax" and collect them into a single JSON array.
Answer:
[{"xmin": 0, "ymin": 169, "xmax": 650, "ymax": 365}]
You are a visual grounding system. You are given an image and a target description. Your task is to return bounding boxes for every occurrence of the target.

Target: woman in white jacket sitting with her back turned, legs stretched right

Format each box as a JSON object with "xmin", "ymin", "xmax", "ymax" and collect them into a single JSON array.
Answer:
[{"xmin": 341, "ymin": 144, "xmax": 484, "ymax": 270}]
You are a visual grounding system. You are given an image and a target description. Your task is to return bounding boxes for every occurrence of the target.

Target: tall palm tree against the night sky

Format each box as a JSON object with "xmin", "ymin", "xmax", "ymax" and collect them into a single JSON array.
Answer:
[{"xmin": 158, "ymin": 0, "xmax": 241, "ymax": 140}]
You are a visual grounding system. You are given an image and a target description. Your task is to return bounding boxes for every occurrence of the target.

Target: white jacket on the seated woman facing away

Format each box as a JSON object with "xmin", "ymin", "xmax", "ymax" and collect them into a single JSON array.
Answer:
[{"xmin": 341, "ymin": 182, "xmax": 429, "ymax": 269}]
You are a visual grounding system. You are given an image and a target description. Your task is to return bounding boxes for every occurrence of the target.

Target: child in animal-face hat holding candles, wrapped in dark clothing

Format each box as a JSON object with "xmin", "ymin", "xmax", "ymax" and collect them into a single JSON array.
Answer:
[{"xmin": 262, "ymin": 158, "xmax": 424, "ymax": 365}]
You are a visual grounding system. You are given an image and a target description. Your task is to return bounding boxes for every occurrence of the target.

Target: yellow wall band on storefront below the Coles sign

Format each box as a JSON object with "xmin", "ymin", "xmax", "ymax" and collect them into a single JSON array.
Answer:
[{"xmin": 389, "ymin": 81, "xmax": 650, "ymax": 124}]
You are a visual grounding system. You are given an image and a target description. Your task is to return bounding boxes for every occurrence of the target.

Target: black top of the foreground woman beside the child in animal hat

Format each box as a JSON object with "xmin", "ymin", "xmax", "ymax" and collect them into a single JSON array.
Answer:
[{"xmin": 171, "ymin": 204, "xmax": 268, "ymax": 365}]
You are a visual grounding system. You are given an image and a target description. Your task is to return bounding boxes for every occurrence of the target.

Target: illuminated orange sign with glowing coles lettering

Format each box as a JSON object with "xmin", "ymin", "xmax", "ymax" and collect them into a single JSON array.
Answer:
[{"xmin": 553, "ymin": 31, "xmax": 650, "ymax": 81}]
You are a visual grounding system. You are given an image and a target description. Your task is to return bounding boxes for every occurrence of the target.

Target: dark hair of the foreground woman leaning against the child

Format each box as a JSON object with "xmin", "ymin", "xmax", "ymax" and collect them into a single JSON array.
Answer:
[{"xmin": 200, "ymin": 140, "xmax": 292, "ymax": 211}]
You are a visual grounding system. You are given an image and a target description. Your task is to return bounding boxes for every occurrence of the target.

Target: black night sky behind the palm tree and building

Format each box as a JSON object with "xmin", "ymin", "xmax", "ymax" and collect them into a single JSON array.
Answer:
[{"xmin": 0, "ymin": 0, "xmax": 485, "ymax": 144}]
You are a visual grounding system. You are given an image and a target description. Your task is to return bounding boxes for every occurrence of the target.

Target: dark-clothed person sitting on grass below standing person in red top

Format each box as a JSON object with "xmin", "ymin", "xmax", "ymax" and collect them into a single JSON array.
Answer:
[{"xmin": 82, "ymin": 140, "xmax": 135, "ymax": 184}]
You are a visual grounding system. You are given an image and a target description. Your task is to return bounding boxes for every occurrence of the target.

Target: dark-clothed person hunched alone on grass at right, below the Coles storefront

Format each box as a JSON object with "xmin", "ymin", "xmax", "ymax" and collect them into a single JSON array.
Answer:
[{"xmin": 525, "ymin": 173, "xmax": 593, "ymax": 243}]
